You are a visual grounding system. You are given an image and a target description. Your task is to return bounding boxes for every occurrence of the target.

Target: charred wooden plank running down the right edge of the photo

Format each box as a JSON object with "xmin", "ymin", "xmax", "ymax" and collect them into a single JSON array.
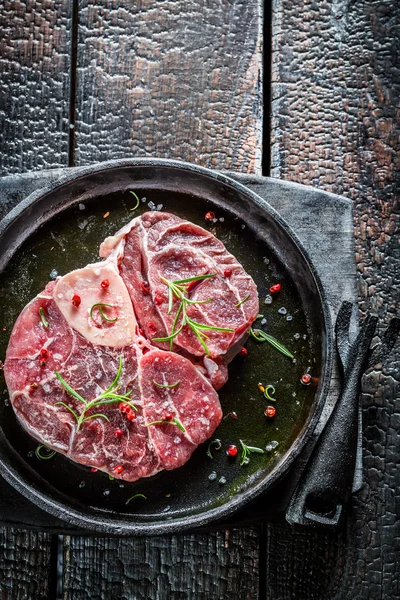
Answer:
[{"xmin": 269, "ymin": 0, "xmax": 400, "ymax": 600}]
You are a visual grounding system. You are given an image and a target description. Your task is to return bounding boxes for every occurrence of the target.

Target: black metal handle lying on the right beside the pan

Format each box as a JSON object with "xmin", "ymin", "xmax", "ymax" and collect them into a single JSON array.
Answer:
[{"xmin": 286, "ymin": 303, "xmax": 400, "ymax": 526}]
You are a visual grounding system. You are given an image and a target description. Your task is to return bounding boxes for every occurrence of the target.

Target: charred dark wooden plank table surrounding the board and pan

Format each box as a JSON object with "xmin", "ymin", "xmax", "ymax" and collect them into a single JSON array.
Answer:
[{"xmin": 0, "ymin": 0, "xmax": 400, "ymax": 600}]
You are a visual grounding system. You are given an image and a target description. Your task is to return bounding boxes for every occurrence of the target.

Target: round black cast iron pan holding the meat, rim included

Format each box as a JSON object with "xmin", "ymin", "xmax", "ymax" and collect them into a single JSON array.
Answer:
[{"xmin": 0, "ymin": 159, "xmax": 332, "ymax": 535}]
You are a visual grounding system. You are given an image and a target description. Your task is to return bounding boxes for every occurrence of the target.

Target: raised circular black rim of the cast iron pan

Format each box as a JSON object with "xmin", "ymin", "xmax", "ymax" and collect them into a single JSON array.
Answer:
[{"xmin": 0, "ymin": 158, "xmax": 334, "ymax": 536}]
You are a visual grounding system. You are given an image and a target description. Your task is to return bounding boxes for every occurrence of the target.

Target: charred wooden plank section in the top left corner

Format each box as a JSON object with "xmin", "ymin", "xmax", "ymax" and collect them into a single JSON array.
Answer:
[{"xmin": 0, "ymin": 0, "xmax": 71, "ymax": 175}]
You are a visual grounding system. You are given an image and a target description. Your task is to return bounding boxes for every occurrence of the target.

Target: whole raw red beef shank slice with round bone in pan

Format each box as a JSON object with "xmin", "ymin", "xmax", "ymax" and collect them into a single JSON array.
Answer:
[{"xmin": 4, "ymin": 213, "xmax": 258, "ymax": 481}]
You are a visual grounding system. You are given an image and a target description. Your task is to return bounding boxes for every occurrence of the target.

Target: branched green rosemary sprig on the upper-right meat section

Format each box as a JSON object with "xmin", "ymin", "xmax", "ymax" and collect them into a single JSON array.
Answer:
[{"xmin": 152, "ymin": 273, "xmax": 233, "ymax": 355}]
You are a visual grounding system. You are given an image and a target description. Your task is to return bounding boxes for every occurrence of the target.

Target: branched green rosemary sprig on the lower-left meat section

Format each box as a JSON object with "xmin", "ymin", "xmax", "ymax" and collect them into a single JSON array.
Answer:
[{"xmin": 54, "ymin": 356, "xmax": 137, "ymax": 432}]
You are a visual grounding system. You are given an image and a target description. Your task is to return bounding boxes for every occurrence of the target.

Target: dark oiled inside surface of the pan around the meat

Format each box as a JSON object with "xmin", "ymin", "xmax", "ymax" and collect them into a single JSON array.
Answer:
[{"xmin": 0, "ymin": 163, "xmax": 326, "ymax": 525}]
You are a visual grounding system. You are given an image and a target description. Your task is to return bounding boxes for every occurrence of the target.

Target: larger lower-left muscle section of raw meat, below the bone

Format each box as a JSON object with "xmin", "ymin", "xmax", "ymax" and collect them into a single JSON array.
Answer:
[{"xmin": 5, "ymin": 282, "xmax": 222, "ymax": 481}]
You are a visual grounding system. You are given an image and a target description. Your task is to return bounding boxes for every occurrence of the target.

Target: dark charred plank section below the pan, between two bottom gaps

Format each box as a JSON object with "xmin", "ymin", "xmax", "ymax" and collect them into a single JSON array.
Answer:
[{"xmin": 63, "ymin": 528, "xmax": 259, "ymax": 600}]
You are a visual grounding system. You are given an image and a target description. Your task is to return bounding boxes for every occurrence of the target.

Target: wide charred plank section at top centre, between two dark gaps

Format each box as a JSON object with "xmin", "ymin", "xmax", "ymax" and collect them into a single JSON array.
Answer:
[{"xmin": 76, "ymin": 0, "xmax": 262, "ymax": 173}]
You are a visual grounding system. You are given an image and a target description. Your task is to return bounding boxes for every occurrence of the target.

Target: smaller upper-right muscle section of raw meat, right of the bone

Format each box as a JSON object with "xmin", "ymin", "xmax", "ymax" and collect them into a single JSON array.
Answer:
[{"xmin": 100, "ymin": 212, "xmax": 259, "ymax": 376}]
